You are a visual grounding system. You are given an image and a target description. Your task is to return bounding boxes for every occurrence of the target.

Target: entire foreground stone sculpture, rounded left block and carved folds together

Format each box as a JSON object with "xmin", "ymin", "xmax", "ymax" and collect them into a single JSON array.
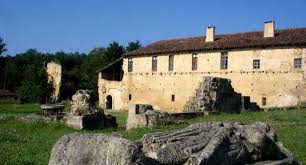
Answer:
[{"xmin": 49, "ymin": 122, "xmax": 293, "ymax": 165}]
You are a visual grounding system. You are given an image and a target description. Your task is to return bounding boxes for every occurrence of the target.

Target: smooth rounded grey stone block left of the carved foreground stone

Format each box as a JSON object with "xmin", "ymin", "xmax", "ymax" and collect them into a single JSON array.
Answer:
[{"xmin": 49, "ymin": 133, "xmax": 145, "ymax": 165}]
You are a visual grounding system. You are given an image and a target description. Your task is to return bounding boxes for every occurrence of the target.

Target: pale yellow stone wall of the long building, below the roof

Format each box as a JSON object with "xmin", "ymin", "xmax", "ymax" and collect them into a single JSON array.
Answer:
[{"xmin": 99, "ymin": 48, "xmax": 306, "ymax": 112}]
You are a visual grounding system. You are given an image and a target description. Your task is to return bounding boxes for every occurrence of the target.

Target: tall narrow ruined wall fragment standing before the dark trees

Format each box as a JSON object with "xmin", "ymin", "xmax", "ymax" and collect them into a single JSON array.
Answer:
[{"xmin": 47, "ymin": 62, "xmax": 62, "ymax": 101}]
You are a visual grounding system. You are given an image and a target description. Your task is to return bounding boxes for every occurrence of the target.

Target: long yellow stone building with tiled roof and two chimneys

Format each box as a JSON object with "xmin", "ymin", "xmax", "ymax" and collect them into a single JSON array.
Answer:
[{"xmin": 98, "ymin": 21, "xmax": 306, "ymax": 112}]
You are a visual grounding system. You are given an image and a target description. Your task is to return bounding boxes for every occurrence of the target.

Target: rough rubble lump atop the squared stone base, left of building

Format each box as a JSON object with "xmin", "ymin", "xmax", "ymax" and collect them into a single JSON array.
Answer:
[{"xmin": 69, "ymin": 89, "xmax": 95, "ymax": 116}]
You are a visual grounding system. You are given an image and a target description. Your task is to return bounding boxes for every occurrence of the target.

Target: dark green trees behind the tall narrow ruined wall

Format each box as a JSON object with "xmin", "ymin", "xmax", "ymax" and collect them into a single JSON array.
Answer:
[{"xmin": 0, "ymin": 40, "xmax": 141, "ymax": 102}]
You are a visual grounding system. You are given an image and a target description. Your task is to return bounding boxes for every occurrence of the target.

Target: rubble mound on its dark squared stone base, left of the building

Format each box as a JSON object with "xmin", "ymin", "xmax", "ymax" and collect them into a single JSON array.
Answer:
[{"xmin": 63, "ymin": 89, "xmax": 117, "ymax": 129}]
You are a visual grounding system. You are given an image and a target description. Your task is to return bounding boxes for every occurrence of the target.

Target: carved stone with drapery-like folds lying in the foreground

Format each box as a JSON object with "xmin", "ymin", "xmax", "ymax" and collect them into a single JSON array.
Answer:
[{"xmin": 143, "ymin": 123, "xmax": 292, "ymax": 164}]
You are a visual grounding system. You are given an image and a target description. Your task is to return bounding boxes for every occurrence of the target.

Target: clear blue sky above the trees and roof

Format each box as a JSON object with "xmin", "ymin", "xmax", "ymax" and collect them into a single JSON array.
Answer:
[{"xmin": 0, "ymin": 0, "xmax": 306, "ymax": 55}]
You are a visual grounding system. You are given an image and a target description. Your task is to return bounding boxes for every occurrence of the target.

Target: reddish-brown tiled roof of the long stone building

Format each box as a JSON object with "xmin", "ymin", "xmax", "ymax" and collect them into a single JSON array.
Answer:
[{"xmin": 124, "ymin": 28, "xmax": 306, "ymax": 56}]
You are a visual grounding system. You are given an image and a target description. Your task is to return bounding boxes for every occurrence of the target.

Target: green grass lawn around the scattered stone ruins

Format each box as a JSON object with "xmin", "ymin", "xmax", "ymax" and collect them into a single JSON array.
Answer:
[{"xmin": 0, "ymin": 104, "xmax": 306, "ymax": 164}]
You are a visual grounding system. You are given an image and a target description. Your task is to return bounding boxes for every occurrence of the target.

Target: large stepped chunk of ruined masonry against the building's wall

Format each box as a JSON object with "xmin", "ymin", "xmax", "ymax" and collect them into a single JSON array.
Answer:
[{"xmin": 184, "ymin": 76, "xmax": 241, "ymax": 113}]
